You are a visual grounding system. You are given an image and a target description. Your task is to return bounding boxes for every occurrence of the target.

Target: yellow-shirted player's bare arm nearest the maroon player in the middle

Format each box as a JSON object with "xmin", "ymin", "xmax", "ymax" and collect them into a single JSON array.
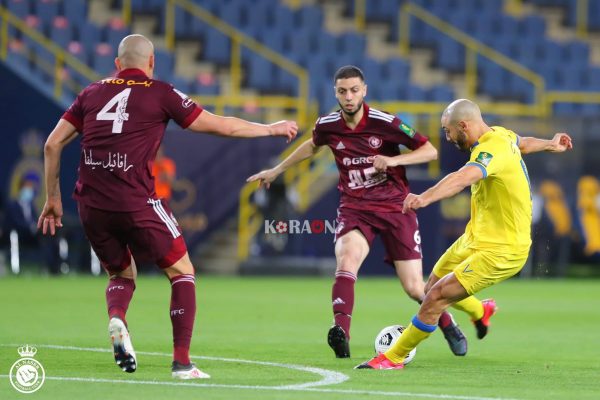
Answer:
[{"xmin": 402, "ymin": 165, "xmax": 483, "ymax": 213}]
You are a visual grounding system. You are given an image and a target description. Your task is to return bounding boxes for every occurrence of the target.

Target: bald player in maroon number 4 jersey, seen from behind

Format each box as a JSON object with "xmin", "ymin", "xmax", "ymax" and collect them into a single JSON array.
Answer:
[{"xmin": 38, "ymin": 35, "xmax": 298, "ymax": 379}]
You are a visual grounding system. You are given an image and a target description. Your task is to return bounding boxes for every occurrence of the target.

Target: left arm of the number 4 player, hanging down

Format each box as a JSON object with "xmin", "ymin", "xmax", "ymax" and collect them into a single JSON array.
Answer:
[{"xmin": 38, "ymin": 119, "xmax": 77, "ymax": 236}]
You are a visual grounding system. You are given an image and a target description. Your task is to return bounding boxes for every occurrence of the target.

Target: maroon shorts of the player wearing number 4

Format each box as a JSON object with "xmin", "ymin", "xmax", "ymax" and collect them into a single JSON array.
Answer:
[{"xmin": 78, "ymin": 200, "xmax": 187, "ymax": 273}]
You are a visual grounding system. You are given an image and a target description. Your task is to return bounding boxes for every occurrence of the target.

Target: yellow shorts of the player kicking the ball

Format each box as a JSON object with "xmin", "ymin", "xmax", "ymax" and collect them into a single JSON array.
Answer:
[{"xmin": 433, "ymin": 235, "xmax": 529, "ymax": 295}]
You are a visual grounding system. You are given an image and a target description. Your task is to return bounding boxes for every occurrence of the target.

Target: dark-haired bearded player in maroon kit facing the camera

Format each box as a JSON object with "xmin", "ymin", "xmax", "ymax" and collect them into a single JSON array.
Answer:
[{"xmin": 248, "ymin": 65, "xmax": 467, "ymax": 358}]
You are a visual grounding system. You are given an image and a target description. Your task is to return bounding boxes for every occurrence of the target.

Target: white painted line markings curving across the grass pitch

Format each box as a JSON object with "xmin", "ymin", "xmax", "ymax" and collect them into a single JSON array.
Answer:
[{"xmin": 0, "ymin": 344, "xmax": 517, "ymax": 400}]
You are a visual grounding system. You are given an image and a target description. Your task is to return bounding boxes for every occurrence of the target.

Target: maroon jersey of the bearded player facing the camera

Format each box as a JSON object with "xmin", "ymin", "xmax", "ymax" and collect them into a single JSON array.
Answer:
[{"xmin": 313, "ymin": 103, "xmax": 428, "ymax": 212}]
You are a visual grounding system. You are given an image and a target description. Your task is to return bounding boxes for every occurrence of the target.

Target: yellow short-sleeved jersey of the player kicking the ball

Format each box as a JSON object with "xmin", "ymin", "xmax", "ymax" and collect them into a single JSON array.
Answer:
[{"xmin": 465, "ymin": 126, "xmax": 532, "ymax": 254}]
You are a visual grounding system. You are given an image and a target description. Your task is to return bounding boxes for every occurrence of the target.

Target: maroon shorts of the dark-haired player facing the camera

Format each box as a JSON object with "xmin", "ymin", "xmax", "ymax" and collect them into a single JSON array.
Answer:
[{"xmin": 335, "ymin": 207, "xmax": 422, "ymax": 265}]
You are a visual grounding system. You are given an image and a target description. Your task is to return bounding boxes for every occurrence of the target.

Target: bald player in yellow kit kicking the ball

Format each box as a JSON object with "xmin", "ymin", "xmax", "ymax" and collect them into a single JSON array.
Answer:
[{"xmin": 356, "ymin": 99, "xmax": 573, "ymax": 369}]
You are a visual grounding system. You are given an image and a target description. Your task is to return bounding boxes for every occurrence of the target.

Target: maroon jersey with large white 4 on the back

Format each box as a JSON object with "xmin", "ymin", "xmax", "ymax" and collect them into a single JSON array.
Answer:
[{"xmin": 62, "ymin": 69, "xmax": 202, "ymax": 212}]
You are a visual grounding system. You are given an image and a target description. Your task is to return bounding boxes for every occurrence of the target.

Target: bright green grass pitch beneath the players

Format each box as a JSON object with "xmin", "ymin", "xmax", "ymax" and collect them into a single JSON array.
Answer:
[{"xmin": 0, "ymin": 276, "xmax": 600, "ymax": 400}]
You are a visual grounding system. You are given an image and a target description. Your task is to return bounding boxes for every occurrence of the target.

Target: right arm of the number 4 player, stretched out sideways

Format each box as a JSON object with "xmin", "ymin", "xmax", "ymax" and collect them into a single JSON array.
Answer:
[{"xmin": 188, "ymin": 110, "xmax": 298, "ymax": 143}]
